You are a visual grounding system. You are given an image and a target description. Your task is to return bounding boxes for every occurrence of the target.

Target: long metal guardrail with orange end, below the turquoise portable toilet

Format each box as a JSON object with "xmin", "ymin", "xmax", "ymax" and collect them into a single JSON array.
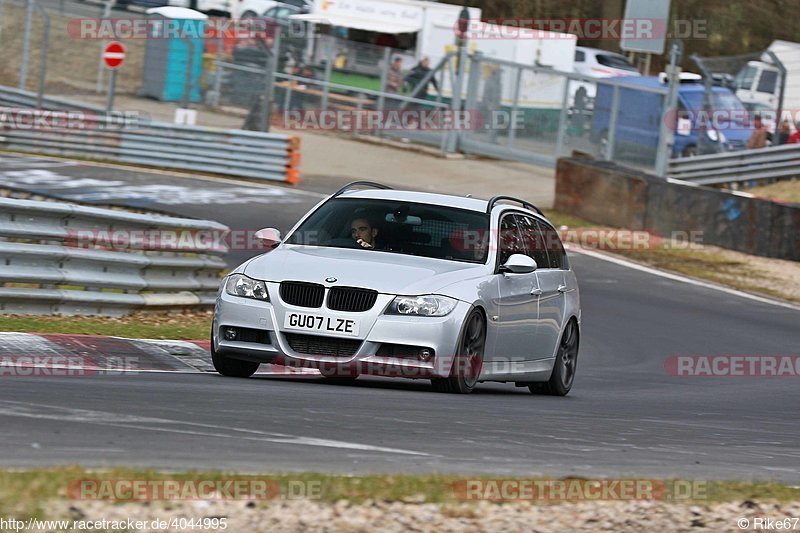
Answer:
[{"xmin": 0, "ymin": 87, "xmax": 300, "ymax": 183}]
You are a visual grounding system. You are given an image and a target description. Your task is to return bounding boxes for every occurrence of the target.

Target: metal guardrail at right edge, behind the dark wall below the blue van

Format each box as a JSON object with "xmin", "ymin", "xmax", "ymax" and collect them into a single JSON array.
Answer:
[{"xmin": 668, "ymin": 144, "xmax": 800, "ymax": 185}]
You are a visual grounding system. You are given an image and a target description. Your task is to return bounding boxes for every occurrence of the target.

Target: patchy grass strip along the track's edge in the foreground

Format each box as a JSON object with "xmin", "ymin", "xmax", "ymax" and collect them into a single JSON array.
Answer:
[{"xmin": 0, "ymin": 467, "xmax": 800, "ymax": 518}]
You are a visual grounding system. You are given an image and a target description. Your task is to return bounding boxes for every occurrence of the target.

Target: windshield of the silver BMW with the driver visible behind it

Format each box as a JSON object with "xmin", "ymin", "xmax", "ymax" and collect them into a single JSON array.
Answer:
[{"xmin": 286, "ymin": 198, "xmax": 489, "ymax": 263}]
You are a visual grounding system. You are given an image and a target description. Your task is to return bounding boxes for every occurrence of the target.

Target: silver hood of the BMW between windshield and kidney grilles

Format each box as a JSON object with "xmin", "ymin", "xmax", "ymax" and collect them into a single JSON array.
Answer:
[{"xmin": 244, "ymin": 245, "xmax": 486, "ymax": 295}]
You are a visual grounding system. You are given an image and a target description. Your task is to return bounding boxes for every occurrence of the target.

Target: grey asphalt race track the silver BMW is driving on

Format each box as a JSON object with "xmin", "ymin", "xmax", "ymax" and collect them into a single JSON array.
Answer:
[{"xmin": 0, "ymin": 156, "xmax": 800, "ymax": 483}]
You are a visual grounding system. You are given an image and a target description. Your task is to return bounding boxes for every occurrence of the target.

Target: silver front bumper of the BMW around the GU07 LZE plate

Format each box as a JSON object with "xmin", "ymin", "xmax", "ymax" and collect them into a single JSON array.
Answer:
[{"xmin": 211, "ymin": 283, "xmax": 471, "ymax": 378}]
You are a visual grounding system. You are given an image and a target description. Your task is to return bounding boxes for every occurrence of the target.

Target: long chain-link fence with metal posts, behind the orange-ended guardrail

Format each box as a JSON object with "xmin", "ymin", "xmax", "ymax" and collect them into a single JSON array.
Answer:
[{"xmin": 0, "ymin": 0, "xmax": 667, "ymax": 170}]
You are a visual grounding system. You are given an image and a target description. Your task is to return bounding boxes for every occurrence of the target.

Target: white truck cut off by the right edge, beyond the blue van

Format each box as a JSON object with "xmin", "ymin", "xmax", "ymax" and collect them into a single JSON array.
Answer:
[{"xmin": 734, "ymin": 41, "xmax": 800, "ymax": 123}]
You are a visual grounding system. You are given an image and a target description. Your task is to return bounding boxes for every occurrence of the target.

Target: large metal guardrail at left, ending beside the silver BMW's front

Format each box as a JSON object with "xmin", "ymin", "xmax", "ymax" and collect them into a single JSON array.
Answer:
[{"xmin": 0, "ymin": 198, "xmax": 229, "ymax": 316}]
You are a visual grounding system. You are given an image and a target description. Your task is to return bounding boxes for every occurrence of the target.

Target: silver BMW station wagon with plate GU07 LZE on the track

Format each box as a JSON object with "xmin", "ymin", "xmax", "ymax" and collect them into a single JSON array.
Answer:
[{"xmin": 211, "ymin": 181, "xmax": 581, "ymax": 396}]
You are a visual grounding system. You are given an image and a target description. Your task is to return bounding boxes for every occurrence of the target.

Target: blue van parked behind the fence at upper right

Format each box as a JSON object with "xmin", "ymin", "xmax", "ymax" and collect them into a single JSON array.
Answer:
[{"xmin": 591, "ymin": 76, "xmax": 753, "ymax": 157}]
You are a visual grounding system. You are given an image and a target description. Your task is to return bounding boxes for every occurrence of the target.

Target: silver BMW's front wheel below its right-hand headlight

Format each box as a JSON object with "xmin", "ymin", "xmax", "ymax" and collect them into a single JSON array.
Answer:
[{"xmin": 431, "ymin": 309, "xmax": 486, "ymax": 394}]
